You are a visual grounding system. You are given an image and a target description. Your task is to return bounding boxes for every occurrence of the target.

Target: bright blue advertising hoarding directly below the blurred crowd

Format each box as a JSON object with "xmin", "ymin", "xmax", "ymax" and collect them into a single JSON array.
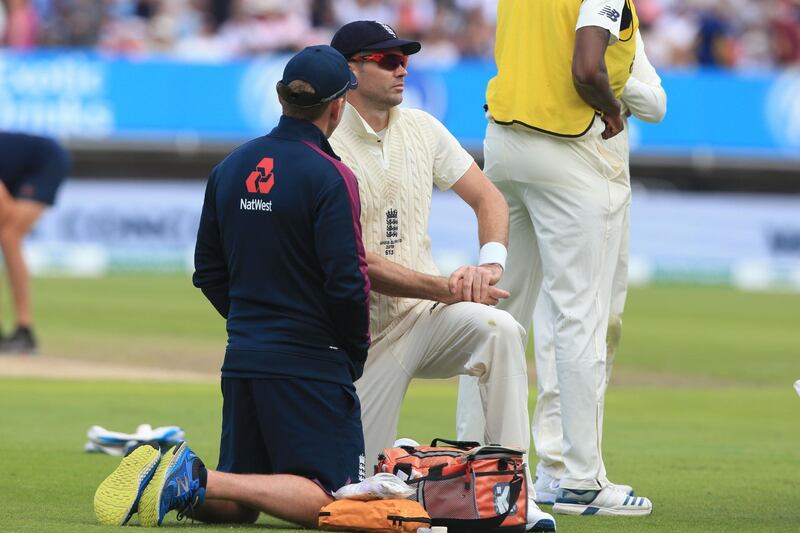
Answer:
[{"xmin": 0, "ymin": 52, "xmax": 800, "ymax": 160}]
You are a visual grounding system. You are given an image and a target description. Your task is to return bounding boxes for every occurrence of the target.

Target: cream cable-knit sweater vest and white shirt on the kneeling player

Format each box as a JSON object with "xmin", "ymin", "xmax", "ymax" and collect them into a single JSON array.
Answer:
[{"xmin": 330, "ymin": 105, "xmax": 473, "ymax": 342}]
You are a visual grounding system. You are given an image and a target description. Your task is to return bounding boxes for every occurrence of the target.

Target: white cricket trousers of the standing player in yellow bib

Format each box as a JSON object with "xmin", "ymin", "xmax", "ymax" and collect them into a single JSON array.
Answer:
[{"xmin": 457, "ymin": 120, "xmax": 630, "ymax": 489}]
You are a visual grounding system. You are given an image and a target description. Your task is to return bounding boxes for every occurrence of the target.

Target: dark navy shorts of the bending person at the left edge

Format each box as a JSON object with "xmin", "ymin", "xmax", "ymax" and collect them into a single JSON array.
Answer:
[{"xmin": 0, "ymin": 132, "xmax": 69, "ymax": 205}]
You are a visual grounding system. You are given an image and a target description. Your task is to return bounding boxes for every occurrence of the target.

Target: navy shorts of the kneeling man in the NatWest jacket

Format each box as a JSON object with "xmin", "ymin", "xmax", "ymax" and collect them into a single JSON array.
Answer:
[{"xmin": 217, "ymin": 378, "xmax": 364, "ymax": 492}]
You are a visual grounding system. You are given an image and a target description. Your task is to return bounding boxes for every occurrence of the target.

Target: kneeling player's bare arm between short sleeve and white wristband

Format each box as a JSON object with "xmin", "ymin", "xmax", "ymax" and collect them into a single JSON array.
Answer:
[{"xmin": 453, "ymin": 163, "xmax": 508, "ymax": 246}]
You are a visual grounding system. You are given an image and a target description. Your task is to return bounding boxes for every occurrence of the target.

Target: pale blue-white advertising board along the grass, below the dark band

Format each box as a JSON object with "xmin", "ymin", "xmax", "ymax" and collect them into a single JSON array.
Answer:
[{"xmin": 26, "ymin": 181, "xmax": 800, "ymax": 290}]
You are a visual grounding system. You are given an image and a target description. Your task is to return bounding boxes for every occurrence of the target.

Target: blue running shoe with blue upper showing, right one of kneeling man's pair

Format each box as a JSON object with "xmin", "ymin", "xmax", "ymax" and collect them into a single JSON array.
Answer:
[{"xmin": 139, "ymin": 442, "xmax": 207, "ymax": 527}]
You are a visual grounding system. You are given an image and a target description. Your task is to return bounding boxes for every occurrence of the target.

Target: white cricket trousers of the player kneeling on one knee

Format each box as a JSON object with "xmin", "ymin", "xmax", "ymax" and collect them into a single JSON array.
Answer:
[{"xmin": 355, "ymin": 302, "xmax": 530, "ymax": 472}]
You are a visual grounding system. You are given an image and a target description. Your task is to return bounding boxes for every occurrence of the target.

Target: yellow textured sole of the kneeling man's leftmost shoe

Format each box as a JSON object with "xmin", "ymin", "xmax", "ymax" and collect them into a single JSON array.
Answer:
[{"xmin": 94, "ymin": 445, "xmax": 161, "ymax": 526}]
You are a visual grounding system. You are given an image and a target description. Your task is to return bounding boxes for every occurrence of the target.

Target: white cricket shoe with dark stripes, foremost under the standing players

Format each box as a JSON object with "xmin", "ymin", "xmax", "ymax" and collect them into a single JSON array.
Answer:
[{"xmin": 553, "ymin": 487, "xmax": 653, "ymax": 516}]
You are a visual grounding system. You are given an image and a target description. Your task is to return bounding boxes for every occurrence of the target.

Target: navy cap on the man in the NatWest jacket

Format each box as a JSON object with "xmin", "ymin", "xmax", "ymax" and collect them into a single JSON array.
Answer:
[{"xmin": 277, "ymin": 44, "xmax": 358, "ymax": 107}]
